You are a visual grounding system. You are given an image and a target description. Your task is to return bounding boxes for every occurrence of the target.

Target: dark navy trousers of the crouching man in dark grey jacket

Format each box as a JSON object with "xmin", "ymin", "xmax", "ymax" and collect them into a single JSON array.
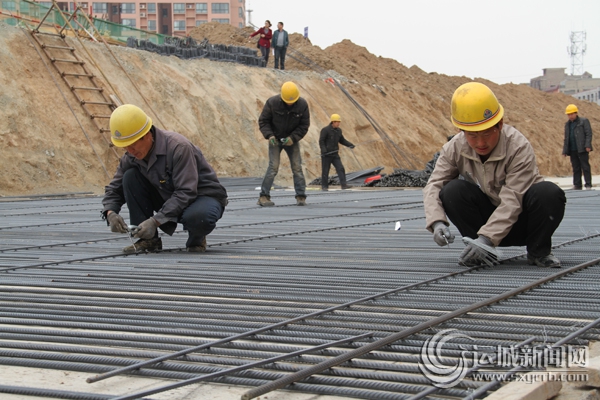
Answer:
[{"xmin": 123, "ymin": 168, "xmax": 225, "ymax": 247}]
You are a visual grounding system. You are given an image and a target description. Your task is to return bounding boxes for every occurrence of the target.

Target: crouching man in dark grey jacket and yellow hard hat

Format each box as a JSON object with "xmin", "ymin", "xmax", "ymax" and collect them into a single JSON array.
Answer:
[{"xmin": 102, "ymin": 104, "xmax": 227, "ymax": 253}]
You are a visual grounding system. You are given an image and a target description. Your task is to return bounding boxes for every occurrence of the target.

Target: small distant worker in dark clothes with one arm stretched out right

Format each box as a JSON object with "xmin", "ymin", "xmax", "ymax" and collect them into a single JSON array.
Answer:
[{"xmin": 319, "ymin": 114, "xmax": 354, "ymax": 191}]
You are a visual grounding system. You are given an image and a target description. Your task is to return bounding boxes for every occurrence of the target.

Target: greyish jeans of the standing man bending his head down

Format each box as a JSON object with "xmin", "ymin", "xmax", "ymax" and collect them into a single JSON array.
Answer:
[{"xmin": 260, "ymin": 143, "xmax": 306, "ymax": 197}]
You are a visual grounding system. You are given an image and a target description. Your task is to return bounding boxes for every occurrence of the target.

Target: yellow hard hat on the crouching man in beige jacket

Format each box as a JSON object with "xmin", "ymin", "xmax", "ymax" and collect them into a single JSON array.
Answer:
[{"xmin": 452, "ymin": 82, "xmax": 504, "ymax": 131}]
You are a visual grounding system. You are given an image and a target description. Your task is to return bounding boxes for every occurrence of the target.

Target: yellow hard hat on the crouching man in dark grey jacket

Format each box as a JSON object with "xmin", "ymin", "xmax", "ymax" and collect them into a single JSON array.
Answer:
[{"xmin": 110, "ymin": 104, "xmax": 152, "ymax": 147}]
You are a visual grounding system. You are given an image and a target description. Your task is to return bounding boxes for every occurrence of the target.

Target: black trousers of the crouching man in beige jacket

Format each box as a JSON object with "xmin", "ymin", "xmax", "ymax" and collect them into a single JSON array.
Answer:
[{"xmin": 440, "ymin": 179, "xmax": 567, "ymax": 257}]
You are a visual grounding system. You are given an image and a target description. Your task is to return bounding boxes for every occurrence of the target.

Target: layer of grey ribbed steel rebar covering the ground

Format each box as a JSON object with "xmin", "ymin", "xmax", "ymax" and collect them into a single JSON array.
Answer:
[{"xmin": 0, "ymin": 188, "xmax": 600, "ymax": 399}]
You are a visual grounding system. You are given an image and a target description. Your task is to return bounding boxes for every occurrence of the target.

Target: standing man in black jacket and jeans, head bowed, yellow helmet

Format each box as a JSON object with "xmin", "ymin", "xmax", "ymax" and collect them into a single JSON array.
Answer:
[{"xmin": 257, "ymin": 82, "xmax": 310, "ymax": 207}]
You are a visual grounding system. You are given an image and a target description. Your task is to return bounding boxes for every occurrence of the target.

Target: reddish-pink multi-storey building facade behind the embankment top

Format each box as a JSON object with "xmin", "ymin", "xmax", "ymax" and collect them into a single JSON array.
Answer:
[{"xmin": 39, "ymin": 0, "xmax": 246, "ymax": 36}]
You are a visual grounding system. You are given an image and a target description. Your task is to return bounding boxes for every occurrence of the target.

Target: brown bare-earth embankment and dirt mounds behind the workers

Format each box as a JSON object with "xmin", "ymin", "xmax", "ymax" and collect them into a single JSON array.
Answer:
[{"xmin": 0, "ymin": 21, "xmax": 600, "ymax": 196}]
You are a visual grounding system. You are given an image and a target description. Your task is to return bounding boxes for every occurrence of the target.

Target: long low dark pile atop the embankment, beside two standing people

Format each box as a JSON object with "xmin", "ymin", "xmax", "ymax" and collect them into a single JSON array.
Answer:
[{"xmin": 127, "ymin": 37, "xmax": 265, "ymax": 67}]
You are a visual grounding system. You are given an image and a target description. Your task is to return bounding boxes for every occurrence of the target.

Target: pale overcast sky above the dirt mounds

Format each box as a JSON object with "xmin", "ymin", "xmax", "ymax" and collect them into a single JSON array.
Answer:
[{"xmin": 246, "ymin": 0, "xmax": 600, "ymax": 83}]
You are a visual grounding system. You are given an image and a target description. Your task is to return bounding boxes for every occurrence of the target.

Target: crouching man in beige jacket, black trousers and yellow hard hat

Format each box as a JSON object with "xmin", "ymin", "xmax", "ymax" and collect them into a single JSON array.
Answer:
[{"xmin": 423, "ymin": 82, "xmax": 566, "ymax": 268}]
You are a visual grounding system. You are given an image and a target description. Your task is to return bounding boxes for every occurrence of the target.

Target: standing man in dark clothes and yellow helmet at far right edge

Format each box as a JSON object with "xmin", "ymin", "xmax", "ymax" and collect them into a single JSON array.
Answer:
[{"xmin": 563, "ymin": 104, "xmax": 593, "ymax": 190}]
